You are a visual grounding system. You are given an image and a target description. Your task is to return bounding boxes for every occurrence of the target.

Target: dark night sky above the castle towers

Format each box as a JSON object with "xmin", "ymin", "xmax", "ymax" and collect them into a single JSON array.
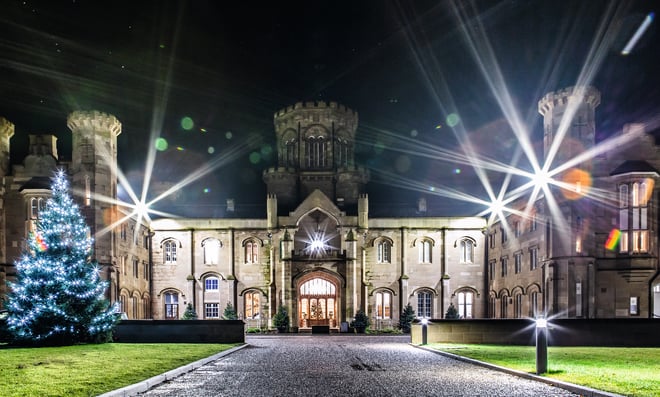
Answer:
[{"xmin": 0, "ymin": 0, "xmax": 660, "ymax": 216}]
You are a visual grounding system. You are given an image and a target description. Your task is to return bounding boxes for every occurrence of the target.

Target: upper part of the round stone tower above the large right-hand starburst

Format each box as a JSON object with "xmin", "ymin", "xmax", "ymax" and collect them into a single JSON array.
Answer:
[{"xmin": 538, "ymin": 86, "xmax": 600, "ymax": 168}]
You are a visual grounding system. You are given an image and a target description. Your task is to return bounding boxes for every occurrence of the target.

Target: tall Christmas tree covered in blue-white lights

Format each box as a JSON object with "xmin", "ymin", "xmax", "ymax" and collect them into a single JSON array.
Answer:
[{"xmin": 7, "ymin": 170, "xmax": 116, "ymax": 345}]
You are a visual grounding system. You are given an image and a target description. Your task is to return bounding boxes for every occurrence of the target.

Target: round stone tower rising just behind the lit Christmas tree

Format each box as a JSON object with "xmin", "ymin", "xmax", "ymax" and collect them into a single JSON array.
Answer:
[{"xmin": 67, "ymin": 111, "xmax": 121, "ymax": 265}]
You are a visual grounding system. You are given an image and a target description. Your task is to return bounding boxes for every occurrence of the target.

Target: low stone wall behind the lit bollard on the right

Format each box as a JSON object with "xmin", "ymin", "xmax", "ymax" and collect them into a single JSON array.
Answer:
[{"xmin": 411, "ymin": 318, "xmax": 660, "ymax": 347}]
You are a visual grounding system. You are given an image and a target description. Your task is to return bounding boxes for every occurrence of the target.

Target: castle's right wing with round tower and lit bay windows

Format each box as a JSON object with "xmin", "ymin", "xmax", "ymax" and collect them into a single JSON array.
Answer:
[{"xmin": 487, "ymin": 88, "xmax": 660, "ymax": 318}]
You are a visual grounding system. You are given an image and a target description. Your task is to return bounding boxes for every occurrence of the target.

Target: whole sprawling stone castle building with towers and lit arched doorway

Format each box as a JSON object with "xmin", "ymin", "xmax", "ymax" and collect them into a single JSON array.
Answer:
[{"xmin": 0, "ymin": 88, "xmax": 660, "ymax": 332}]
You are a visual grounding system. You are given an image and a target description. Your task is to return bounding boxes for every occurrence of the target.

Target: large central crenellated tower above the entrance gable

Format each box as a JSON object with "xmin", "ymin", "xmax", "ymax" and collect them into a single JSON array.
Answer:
[{"xmin": 263, "ymin": 101, "xmax": 369, "ymax": 207}]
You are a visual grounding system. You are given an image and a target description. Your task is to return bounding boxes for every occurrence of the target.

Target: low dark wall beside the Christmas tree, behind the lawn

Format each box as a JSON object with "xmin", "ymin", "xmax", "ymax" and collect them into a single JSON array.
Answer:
[{"xmin": 114, "ymin": 320, "xmax": 245, "ymax": 343}]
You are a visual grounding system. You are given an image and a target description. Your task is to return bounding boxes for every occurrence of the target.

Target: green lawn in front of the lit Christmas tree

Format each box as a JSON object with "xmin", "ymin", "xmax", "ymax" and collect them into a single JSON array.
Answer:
[{"xmin": 0, "ymin": 343, "xmax": 238, "ymax": 397}]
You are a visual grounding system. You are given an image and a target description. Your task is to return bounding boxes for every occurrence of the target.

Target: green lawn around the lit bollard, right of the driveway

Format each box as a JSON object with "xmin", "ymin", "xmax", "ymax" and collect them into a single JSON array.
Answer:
[{"xmin": 428, "ymin": 343, "xmax": 660, "ymax": 396}]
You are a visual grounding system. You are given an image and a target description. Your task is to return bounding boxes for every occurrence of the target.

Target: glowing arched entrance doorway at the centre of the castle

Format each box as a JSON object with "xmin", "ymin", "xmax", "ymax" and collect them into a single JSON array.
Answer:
[{"xmin": 298, "ymin": 272, "xmax": 339, "ymax": 329}]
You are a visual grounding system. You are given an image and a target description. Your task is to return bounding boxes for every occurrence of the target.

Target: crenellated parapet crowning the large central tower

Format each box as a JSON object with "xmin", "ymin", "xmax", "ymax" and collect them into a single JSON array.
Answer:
[{"xmin": 273, "ymin": 101, "xmax": 358, "ymax": 139}]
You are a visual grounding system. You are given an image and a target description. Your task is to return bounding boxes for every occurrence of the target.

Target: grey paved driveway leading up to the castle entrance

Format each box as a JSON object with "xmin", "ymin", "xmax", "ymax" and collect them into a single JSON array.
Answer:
[{"xmin": 143, "ymin": 335, "xmax": 576, "ymax": 397}]
